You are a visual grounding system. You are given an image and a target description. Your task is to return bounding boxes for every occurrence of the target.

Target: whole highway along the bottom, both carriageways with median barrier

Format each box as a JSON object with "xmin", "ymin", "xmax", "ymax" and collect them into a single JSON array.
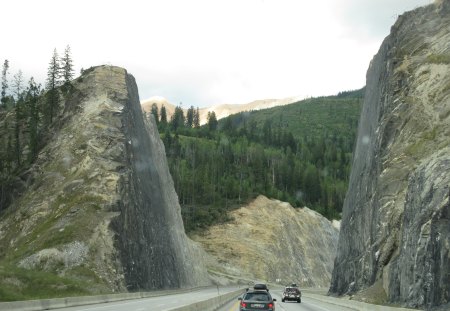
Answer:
[{"xmin": 0, "ymin": 286, "xmax": 420, "ymax": 311}]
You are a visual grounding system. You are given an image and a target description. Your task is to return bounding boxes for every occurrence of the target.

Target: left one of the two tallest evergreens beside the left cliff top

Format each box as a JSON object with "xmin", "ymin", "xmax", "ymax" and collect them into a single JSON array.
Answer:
[{"xmin": 45, "ymin": 49, "xmax": 60, "ymax": 124}]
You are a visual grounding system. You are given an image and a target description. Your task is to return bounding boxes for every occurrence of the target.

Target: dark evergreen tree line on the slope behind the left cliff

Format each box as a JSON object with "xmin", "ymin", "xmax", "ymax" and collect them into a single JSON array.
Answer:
[{"xmin": 0, "ymin": 45, "xmax": 74, "ymax": 211}]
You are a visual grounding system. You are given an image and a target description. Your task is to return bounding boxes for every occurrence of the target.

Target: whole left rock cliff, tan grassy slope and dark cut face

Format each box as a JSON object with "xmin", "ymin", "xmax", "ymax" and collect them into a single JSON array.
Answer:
[{"xmin": 0, "ymin": 66, "xmax": 209, "ymax": 294}]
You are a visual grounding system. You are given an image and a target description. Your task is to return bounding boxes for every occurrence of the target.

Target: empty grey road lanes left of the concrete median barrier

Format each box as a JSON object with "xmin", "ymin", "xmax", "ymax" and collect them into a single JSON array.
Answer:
[{"xmin": 47, "ymin": 287, "xmax": 238, "ymax": 311}]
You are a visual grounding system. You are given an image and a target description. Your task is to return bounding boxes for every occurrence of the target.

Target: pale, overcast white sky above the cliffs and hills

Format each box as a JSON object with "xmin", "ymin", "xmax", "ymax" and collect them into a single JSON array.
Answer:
[{"xmin": 0, "ymin": 0, "xmax": 433, "ymax": 108}]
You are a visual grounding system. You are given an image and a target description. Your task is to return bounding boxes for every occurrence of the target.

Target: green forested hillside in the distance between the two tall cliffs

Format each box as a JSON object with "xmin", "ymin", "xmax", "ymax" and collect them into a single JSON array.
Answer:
[{"xmin": 152, "ymin": 89, "xmax": 364, "ymax": 232}]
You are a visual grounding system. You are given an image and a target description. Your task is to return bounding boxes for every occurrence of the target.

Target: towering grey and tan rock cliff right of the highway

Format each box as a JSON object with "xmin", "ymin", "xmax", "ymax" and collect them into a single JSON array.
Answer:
[{"xmin": 330, "ymin": 0, "xmax": 450, "ymax": 307}]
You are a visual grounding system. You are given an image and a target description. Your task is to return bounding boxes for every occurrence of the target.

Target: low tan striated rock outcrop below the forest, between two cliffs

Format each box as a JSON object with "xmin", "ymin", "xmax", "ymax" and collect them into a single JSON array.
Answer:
[{"xmin": 192, "ymin": 196, "xmax": 339, "ymax": 287}]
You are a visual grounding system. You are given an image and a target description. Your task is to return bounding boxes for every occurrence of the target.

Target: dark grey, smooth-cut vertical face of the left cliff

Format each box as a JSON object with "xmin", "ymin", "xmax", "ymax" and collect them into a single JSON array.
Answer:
[{"xmin": 113, "ymin": 70, "xmax": 207, "ymax": 289}]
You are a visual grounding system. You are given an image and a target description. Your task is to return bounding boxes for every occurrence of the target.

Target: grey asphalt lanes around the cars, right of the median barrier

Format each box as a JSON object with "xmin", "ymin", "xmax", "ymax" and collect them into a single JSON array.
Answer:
[{"xmin": 218, "ymin": 290, "xmax": 355, "ymax": 311}]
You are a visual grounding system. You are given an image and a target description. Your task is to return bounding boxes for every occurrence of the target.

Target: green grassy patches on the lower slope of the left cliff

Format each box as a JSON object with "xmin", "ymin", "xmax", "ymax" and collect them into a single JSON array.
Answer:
[{"xmin": 0, "ymin": 192, "xmax": 109, "ymax": 301}]
